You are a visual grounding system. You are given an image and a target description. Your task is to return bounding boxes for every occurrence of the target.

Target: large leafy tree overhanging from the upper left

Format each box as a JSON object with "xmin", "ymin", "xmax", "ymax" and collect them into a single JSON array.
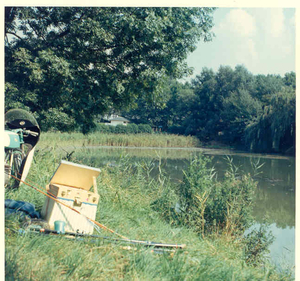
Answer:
[{"xmin": 5, "ymin": 7, "xmax": 214, "ymax": 131}]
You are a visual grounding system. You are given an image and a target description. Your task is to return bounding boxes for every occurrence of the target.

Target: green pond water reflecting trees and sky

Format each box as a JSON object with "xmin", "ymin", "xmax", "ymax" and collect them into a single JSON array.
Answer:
[{"xmin": 74, "ymin": 147, "xmax": 295, "ymax": 268}]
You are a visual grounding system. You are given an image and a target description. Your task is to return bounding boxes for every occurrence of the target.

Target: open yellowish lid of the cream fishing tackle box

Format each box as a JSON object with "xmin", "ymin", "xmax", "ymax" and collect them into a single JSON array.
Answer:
[{"xmin": 50, "ymin": 160, "xmax": 100, "ymax": 190}]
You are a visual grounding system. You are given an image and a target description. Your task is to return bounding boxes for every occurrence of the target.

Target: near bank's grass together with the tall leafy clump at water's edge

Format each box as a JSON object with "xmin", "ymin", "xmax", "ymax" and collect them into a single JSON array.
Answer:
[{"xmin": 5, "ymin": 149, "xmax": 292, "ymax": 281}]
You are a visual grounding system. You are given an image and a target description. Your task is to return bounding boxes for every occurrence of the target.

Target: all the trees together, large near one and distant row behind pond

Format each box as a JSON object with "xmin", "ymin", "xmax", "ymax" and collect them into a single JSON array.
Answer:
[{"xmin": 5, "ymin": 7, "xmax": 296, "ymax": 152}]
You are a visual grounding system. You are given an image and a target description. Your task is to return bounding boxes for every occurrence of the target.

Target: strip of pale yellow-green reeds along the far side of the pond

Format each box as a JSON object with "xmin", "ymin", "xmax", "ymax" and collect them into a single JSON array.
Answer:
[{"xmin": 39, "ymin": 132, "xmax": 200, "ymax": 147}]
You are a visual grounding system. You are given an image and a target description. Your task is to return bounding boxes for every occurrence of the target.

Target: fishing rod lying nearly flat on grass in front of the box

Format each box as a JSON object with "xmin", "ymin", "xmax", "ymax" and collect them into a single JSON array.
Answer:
[{"xmin": 23, "ymin": 227, "xmax": 186, "ymax": 249}]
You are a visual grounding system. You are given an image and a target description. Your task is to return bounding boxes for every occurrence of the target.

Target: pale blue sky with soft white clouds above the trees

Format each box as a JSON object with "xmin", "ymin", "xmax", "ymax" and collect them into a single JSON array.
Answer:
[{"xmin": 186, "ymin": 8, "xmax": 296, "ymax": 80}]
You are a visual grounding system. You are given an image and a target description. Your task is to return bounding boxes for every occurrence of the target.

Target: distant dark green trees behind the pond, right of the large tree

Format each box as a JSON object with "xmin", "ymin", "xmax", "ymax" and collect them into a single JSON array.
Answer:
[{"xmin": 123, "ymin": 65, "xmax": 296, "ymax": 153}]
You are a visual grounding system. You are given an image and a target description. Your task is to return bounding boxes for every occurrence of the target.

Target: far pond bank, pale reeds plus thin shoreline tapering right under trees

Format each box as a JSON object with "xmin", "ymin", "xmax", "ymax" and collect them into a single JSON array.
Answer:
[{"xmin": 37, "ymin": 132, "xmax": 291, "ymax": 159}]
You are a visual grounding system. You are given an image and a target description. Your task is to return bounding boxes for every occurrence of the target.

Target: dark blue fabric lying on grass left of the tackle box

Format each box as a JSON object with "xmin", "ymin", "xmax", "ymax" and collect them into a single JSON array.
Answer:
[{"xmin": 5, "ymin": 199, "xmax": 41, "ymax": 219}]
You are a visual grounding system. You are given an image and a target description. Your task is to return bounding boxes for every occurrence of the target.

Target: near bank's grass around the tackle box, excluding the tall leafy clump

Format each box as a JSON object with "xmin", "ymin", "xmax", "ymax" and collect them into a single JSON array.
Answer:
[{"xmin": 5, "ymin": 149, "xmax": 291, "ymax": 281}]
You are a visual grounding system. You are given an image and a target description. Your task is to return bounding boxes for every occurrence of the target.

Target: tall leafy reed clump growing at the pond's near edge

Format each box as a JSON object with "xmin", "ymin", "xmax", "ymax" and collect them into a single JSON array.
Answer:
[{"xmin": 173, "ymin": 157, "xmax": 256, "ymax": 235}]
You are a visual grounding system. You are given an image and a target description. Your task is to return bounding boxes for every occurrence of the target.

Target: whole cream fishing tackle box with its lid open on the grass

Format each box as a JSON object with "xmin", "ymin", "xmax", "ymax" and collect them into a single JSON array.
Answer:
[{"xmin": 41, "ymin": 160, "xmax": 100, "ymax": 234}]
